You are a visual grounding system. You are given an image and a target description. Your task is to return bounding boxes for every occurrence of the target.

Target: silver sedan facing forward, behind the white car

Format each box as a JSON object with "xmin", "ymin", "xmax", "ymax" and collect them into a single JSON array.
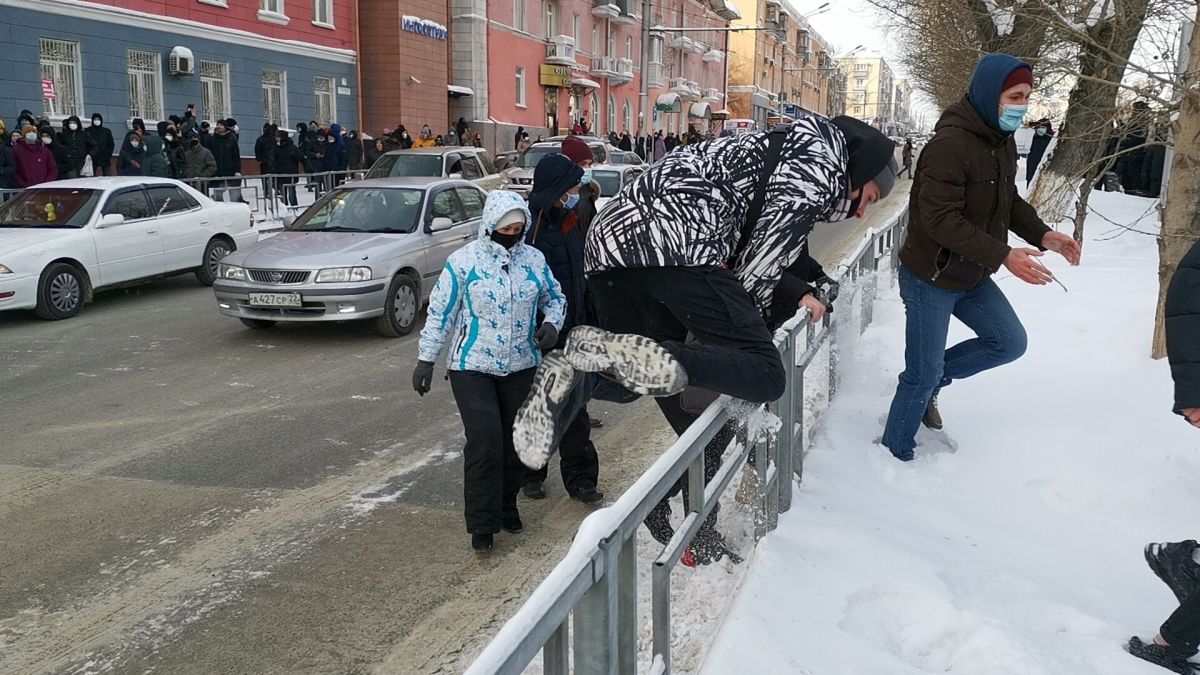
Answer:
[{"xmin": 212, "ymin": 178, "xmax": 486, "ymax": 338}]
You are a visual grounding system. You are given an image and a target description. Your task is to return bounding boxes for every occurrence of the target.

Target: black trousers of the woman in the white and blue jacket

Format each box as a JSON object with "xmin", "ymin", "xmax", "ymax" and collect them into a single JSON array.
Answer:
[{"xmin": 450, "ymin": 368, "xmax": 534, "ymax": 534}]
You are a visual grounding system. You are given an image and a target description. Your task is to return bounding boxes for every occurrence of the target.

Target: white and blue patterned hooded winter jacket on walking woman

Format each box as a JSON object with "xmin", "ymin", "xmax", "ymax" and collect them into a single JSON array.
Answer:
[{"xmin": 419, "ymin": 190, "xmax": 566, "ymax": 376}]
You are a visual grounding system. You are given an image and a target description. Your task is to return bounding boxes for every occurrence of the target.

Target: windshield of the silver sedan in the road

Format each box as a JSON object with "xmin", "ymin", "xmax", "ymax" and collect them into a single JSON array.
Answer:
[{"xmin": 288, "ymin": 187, "xmax": 425, "ymax": 233}]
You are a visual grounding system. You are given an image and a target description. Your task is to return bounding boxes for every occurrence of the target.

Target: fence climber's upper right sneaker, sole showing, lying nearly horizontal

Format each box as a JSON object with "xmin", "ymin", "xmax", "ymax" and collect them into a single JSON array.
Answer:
[{"xmin": 565, "ymin": 325, "xmax": 688, "ymax": 396}]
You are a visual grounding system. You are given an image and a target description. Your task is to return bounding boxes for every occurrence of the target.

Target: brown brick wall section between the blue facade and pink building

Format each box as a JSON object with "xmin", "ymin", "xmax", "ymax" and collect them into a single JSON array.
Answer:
[{"xmin": 359, "ymin": 0, "xmax": 451, "ymax": 137}]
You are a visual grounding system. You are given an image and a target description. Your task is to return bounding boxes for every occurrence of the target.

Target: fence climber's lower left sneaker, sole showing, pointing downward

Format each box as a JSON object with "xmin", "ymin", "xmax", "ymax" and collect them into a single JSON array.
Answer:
[{"xmin": 512, "ymin": 348, "xmax": 586, "ymax": 468}]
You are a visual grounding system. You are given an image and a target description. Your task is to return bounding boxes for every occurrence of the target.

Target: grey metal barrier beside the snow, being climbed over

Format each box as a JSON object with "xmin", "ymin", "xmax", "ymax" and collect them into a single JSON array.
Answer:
[{"xmin": 467, "ymin": 208, "xmax": 908, "ymax": 675}]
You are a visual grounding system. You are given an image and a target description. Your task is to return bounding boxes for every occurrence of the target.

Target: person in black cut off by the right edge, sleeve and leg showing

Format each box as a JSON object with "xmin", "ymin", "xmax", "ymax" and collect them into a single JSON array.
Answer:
[{"xmin": 1126, "ymin": 241, "xmax": 1200, "ymax": 673}]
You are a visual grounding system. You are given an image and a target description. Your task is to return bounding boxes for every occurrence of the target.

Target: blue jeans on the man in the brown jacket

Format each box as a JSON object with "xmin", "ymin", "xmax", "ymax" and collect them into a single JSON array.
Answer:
[{"xmin": 883, "ymin": 265, "xmax": 1026, "ymax": 461}]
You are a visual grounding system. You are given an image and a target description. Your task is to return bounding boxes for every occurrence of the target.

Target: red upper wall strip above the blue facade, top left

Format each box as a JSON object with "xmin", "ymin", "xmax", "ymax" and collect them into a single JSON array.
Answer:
[{"xmin": 78, "ymin": 0, "xmax": 350, "ymax": 49}]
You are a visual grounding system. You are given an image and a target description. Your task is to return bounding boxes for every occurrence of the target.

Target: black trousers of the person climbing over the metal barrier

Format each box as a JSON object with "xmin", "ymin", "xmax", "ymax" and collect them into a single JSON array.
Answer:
[{"xmin": 589, "ymin": 267, "xmax": 786, "ymax": 404}]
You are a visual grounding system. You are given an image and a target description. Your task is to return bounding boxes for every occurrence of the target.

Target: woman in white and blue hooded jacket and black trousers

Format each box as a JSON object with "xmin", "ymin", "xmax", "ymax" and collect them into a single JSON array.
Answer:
[{"xmin": 413, "ymin": 190, "xmax": 565, "ymax": 552}]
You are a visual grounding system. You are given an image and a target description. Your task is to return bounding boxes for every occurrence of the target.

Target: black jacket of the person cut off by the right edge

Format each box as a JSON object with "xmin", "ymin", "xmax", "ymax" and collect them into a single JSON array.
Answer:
[{"xmin": 1164, "ymin": 241, "xmax": 1200, "ymax": 412}]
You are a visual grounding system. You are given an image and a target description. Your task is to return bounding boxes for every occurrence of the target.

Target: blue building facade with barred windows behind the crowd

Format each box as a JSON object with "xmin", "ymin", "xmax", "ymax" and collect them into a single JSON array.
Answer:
[{"xmin": 0, "ymin": 0, "xmax": 359, "ymax": 157}]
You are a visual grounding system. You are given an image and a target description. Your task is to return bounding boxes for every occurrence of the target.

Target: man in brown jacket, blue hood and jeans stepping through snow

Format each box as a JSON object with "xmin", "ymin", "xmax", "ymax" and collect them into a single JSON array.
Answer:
[{"xmin": 881, "ymin": 54, "xmax": 1080, "ymax": 461}]
